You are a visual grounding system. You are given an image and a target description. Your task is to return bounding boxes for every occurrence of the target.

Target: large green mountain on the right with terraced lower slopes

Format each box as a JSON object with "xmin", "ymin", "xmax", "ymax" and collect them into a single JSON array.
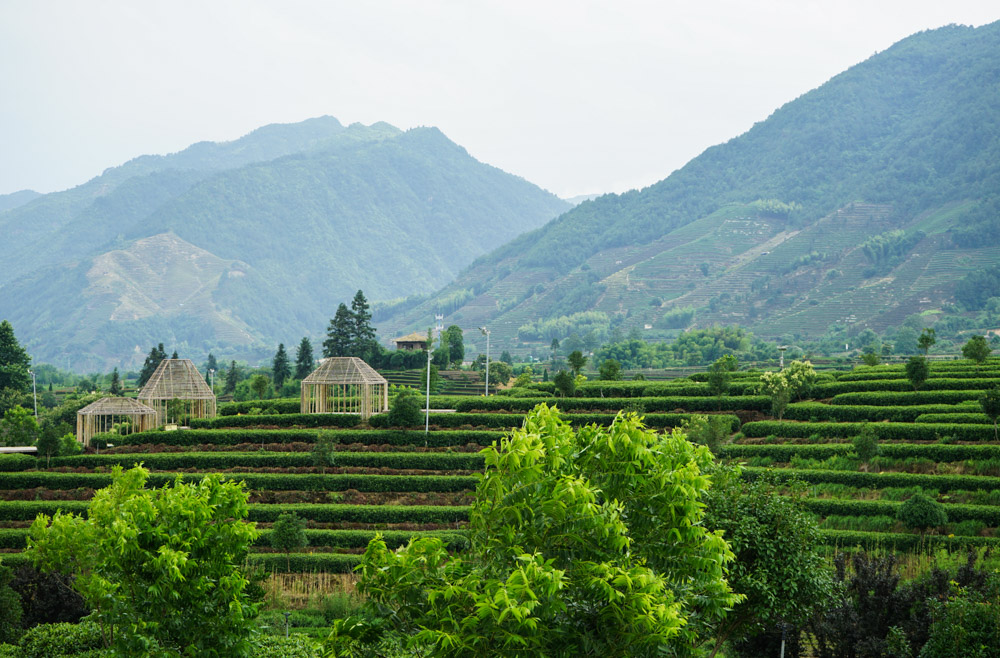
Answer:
[{"xmin": 377, "ymin": 23, "xmax": 1000, "ymax": 355}]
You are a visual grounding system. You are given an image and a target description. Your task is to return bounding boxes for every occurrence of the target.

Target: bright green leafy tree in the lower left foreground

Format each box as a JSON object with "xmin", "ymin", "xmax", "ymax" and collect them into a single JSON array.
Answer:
[{"xmin": 27, "ymin": 466, "xmax": 258, "ymax": 656}]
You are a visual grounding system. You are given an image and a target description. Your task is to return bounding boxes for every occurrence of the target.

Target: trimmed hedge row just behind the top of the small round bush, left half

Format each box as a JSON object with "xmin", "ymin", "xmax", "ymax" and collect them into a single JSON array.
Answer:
[{"xmin": 0, "ymin": 500, "xmax": 469, "ymax": 523}]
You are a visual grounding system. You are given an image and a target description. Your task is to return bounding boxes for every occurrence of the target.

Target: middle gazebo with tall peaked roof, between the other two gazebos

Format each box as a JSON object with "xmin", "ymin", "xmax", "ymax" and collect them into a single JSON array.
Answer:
[{"xmin": 138, "ymin": 359, "xmax": 215, "ymax": 426}]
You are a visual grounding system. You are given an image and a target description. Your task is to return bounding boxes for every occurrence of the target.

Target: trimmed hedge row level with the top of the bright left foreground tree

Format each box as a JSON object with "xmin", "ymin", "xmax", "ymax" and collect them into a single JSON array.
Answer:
[{"xmin": 0, "ymin": 471, "xmax": 478, "ymax": 493}]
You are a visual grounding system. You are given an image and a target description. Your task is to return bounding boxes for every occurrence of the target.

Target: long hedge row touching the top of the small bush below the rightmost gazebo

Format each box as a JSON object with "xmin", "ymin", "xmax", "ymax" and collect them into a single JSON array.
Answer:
[{"xmin": 113, "ymin": 429, "xmax": 503, "ymax": 448}]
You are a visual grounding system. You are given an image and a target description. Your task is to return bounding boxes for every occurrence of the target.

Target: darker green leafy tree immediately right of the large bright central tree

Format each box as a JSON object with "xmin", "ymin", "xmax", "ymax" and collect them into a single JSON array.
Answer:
[{"xmin": 704, "ymin": 466, "xmax": 833, "ymax": 656}]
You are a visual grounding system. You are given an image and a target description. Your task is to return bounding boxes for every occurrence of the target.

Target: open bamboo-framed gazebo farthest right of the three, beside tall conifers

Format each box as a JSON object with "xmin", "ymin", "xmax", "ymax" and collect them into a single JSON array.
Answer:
[{"xmin": 302, "ymin": 356, "xmax": 389, "ymax": 418}]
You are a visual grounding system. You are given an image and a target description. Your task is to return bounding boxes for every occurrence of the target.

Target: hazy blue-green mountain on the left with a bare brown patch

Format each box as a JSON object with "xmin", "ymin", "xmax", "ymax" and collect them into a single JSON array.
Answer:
[{"xmin": 0, "ymin": 117, "xmax": 569, "ymax": 370}]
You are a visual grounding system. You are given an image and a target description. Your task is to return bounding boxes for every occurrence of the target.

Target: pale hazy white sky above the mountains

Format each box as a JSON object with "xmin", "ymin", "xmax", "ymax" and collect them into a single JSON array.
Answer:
[{"xmin": 0, "ymin": 0, "xmax": 1000, "ymax": 197}]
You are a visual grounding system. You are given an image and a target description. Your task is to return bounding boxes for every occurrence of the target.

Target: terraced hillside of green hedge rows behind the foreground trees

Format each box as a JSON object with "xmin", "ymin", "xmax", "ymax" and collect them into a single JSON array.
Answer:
[{"xmin": 0, "ymin": 359, "xmax": 1000, "ymax": 572}]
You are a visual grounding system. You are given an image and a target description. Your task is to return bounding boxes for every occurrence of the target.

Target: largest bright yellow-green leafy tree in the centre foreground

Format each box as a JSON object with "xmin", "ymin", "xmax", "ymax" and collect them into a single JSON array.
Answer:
[{"xmin": 327, "ymin": 405, "xmax": 742, "ymax": 657}]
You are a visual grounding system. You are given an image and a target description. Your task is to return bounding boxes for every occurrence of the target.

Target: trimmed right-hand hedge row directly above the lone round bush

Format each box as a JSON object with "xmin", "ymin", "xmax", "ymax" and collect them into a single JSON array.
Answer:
[{"xmin": 743, "ymin": 467, "xmax": 1000, "ymax": 491}]
